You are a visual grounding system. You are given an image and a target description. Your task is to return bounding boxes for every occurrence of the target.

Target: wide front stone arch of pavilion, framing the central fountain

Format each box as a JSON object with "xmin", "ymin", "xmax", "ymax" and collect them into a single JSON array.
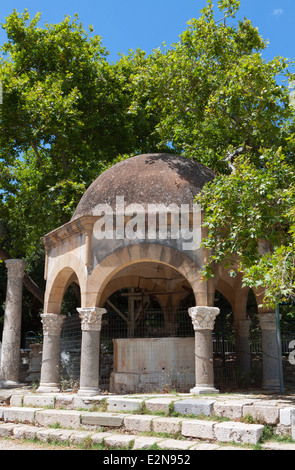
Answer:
[{"xmin": 86, "ymin": 243, "xmax": 206, "ymax": 307}]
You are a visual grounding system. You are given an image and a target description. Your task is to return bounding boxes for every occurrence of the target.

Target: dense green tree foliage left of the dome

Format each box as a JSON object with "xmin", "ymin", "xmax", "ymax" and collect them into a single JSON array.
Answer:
[{"xmin": 0, "ymin": 11, "xmax": 163, "ymax": 258}]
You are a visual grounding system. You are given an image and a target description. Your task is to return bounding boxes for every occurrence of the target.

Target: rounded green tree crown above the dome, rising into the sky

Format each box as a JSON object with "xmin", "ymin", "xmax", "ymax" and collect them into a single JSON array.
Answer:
[{"xmin": 130, "ymin": 1, "xmax": 289, "ymax": 172}]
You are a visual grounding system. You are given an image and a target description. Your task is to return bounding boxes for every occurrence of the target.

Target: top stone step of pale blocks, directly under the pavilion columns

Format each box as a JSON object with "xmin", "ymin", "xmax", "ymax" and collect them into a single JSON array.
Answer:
[{"xmin": 9, "ymin": 393, "xmax": 295, "ymax": 428}]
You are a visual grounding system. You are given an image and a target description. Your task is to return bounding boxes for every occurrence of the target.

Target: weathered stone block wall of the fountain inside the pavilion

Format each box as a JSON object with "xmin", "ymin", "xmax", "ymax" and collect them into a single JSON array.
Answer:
[{"xmin": 110, "ymin": 338, "xmax": 195, "ymax": 393}]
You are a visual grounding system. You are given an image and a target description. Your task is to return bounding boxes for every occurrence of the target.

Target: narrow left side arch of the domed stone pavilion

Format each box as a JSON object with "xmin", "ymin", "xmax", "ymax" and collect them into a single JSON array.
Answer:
[{"xmin": 44, "ymin": 253, "xmax": 87, "ymax": 314}]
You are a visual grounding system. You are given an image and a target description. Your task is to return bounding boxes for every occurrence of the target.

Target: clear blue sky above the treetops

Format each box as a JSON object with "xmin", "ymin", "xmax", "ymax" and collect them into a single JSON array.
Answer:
[{"xmin": 0, "ymin": 0, "xmax": 295, "ymax": 61}]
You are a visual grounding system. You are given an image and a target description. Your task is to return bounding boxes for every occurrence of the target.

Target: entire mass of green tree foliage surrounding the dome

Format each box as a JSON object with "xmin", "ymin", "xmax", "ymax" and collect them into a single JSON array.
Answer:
[{"xmin": 0, "ymin": 0, "xmax": 295, "ymax": 316}]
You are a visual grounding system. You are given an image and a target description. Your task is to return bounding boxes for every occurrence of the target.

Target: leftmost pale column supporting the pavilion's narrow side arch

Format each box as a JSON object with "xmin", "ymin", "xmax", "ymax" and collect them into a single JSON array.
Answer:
[{"xmin": 37, "ymin": 313, "xmax": 65, "ymax": 392}]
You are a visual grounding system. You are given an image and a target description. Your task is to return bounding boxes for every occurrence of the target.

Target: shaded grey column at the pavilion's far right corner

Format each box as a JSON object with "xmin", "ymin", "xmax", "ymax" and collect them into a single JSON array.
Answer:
[{"xmin": 258, "ymin": 313, "xmax": 281, "ymax": 391}]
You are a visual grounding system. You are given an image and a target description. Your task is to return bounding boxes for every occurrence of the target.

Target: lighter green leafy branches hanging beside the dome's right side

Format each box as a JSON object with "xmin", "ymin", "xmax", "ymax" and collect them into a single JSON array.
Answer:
[{"xmin": 197, "ymin": 149, "xmax": 295, "ymax": 306}]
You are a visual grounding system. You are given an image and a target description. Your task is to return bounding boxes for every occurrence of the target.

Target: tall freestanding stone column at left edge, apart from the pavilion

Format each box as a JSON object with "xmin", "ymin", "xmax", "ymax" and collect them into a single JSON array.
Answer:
[{"xmin": 0, "ymin": 259, "xmax": 26, "ymax": 386}]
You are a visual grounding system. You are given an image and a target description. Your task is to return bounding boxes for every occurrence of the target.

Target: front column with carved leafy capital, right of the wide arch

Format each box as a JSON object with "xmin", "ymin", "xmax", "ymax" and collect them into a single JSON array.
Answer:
[{"xmin": 189, "ymin": 307, "xmax": 220, "ymax": 395}]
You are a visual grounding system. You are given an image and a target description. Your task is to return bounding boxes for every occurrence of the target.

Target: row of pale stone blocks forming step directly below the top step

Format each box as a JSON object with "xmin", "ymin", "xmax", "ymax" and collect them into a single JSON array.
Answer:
[{"xmin": 0, "ymin": 406, "xmax": 264, "ymax": 445}]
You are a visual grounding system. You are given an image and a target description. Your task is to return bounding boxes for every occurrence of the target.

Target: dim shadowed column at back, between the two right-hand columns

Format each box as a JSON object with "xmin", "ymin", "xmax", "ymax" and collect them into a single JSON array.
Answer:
[{"xmin": 234, "ymin": 318, "xmax": 251, "ymax": 377}]
